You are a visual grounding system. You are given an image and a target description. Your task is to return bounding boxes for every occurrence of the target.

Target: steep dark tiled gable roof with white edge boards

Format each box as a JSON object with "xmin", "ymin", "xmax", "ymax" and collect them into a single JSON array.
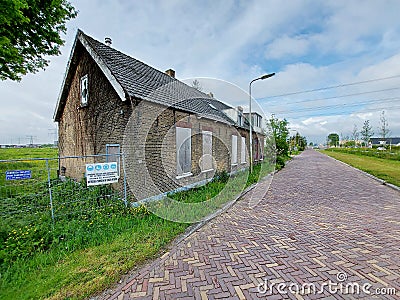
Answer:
[{"xmin": 54, "ymin": 30, "xmax": 235, "ymax": 124}]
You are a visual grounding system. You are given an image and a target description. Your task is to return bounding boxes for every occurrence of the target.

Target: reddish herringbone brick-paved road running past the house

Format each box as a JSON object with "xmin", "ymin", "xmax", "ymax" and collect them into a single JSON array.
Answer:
[{"xmin": 101, "ymin": 150, "xmax": 400, "ymax": 299}]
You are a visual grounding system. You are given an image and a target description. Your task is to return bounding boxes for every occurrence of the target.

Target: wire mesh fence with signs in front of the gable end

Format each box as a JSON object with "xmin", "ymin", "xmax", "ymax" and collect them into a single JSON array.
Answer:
[{"xmin": 0, "ymin": 153, "xmax": 127, "ymax": 225}]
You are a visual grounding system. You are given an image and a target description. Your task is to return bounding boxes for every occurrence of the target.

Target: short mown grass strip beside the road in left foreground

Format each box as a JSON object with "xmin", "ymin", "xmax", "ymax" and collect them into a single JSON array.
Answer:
[{"xmin": 0, "ymin": 215, "xmax": 187, "ymax": 299}]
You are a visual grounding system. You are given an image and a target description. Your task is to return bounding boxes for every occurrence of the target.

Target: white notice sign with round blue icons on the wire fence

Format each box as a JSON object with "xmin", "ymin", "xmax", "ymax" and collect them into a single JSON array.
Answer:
[{"xmin": 86, "ymin": 162, "xmax": 119, "ymax": 186}]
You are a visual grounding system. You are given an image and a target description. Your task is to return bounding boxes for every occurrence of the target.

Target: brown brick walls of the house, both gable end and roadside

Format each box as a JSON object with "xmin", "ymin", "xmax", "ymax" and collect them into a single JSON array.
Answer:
[{"xmin": 59, "ymin": 46, "xmax": 263, "ymax": 199}]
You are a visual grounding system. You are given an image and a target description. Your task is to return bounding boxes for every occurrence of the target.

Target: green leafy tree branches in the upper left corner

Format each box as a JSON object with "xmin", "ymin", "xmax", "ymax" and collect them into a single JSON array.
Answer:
[{"xmin": 0, "ymin": 0, "xmax": 77, "ymax": 81}]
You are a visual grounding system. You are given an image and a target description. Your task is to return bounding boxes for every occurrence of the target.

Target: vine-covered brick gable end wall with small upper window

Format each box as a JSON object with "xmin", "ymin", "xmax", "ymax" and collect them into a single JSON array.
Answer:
[{"xmin": 59, "ymin": 43, "xmax": 131, "ymax": 180}]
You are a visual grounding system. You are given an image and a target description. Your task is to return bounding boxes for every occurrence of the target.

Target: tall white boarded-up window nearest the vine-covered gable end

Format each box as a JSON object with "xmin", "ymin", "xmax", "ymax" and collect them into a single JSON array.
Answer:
[{"xmin": 176, "ymin": 127, "xmax": 192, "ymax": 176}]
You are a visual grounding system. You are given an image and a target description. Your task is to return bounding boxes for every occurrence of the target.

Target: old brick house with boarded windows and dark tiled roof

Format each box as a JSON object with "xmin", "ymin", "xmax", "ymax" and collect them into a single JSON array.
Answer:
[{"xmin": 54, "ymin": 30, "xmax": 264, "ymax": 200}]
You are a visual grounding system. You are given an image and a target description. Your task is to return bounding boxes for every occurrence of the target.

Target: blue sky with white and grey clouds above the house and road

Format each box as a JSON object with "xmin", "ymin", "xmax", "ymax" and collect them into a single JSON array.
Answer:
[{"xmin": 0, "ymin": 0, "xmax": 400, "ymax": 143}]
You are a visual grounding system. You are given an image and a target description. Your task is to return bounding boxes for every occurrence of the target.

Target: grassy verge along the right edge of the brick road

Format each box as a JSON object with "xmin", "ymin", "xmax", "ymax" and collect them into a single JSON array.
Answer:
[{"xmin": 322, "ymin": 150, "xmax": 400, "ymax": 186}]
